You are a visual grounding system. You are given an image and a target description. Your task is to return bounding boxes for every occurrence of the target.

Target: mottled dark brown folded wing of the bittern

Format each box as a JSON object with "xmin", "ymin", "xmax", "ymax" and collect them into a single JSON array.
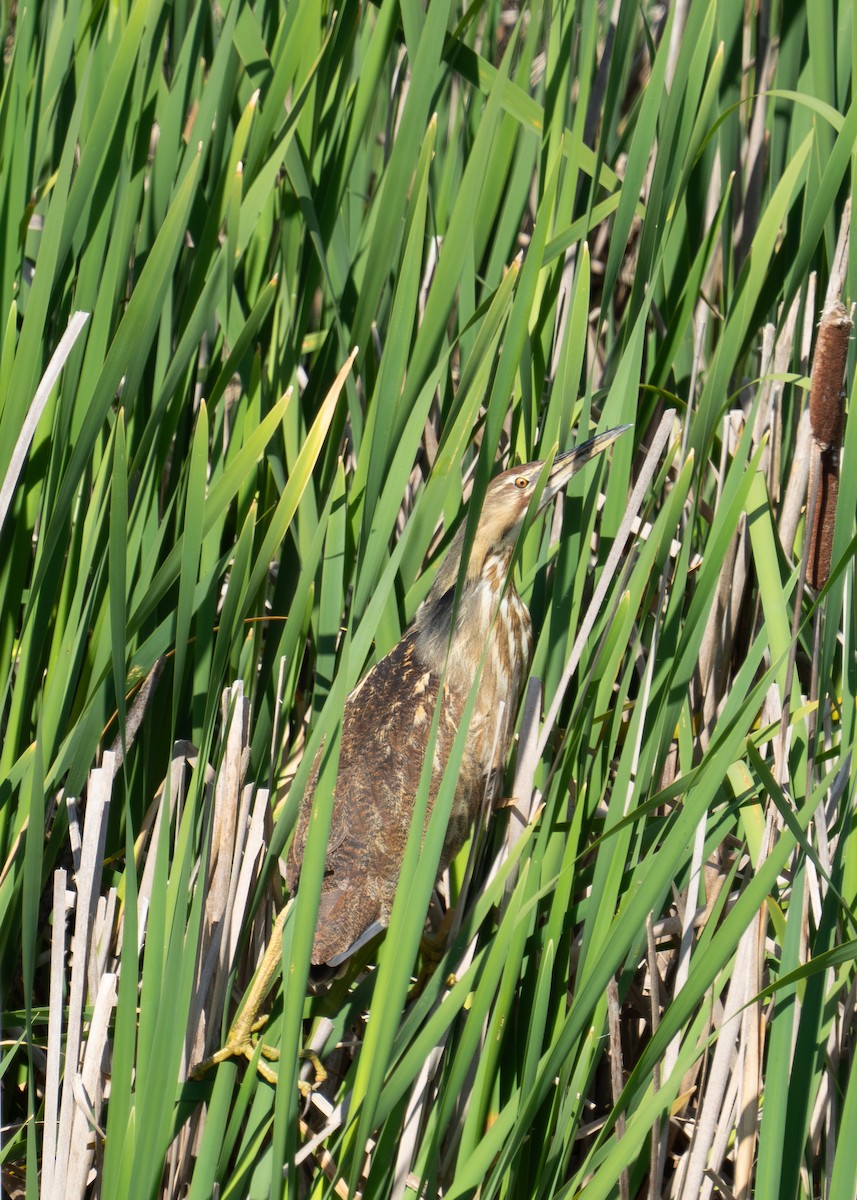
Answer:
[{"xmin": 286, "ymin": 636, "xmax": 455, "ymax": 962}]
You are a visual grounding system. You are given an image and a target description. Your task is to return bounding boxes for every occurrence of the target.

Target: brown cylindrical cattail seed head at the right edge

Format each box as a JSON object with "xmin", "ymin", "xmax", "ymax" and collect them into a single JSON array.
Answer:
[{"xmin": 807, "ymin": 300, "xmax": 851, "ymax": 589}]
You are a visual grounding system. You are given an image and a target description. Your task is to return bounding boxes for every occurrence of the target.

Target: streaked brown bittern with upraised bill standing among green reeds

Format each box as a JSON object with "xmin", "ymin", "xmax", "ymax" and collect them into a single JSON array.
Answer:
[{"xmin": 286, "ymin": 425, "xmax": 630, "ymax": 967}]
